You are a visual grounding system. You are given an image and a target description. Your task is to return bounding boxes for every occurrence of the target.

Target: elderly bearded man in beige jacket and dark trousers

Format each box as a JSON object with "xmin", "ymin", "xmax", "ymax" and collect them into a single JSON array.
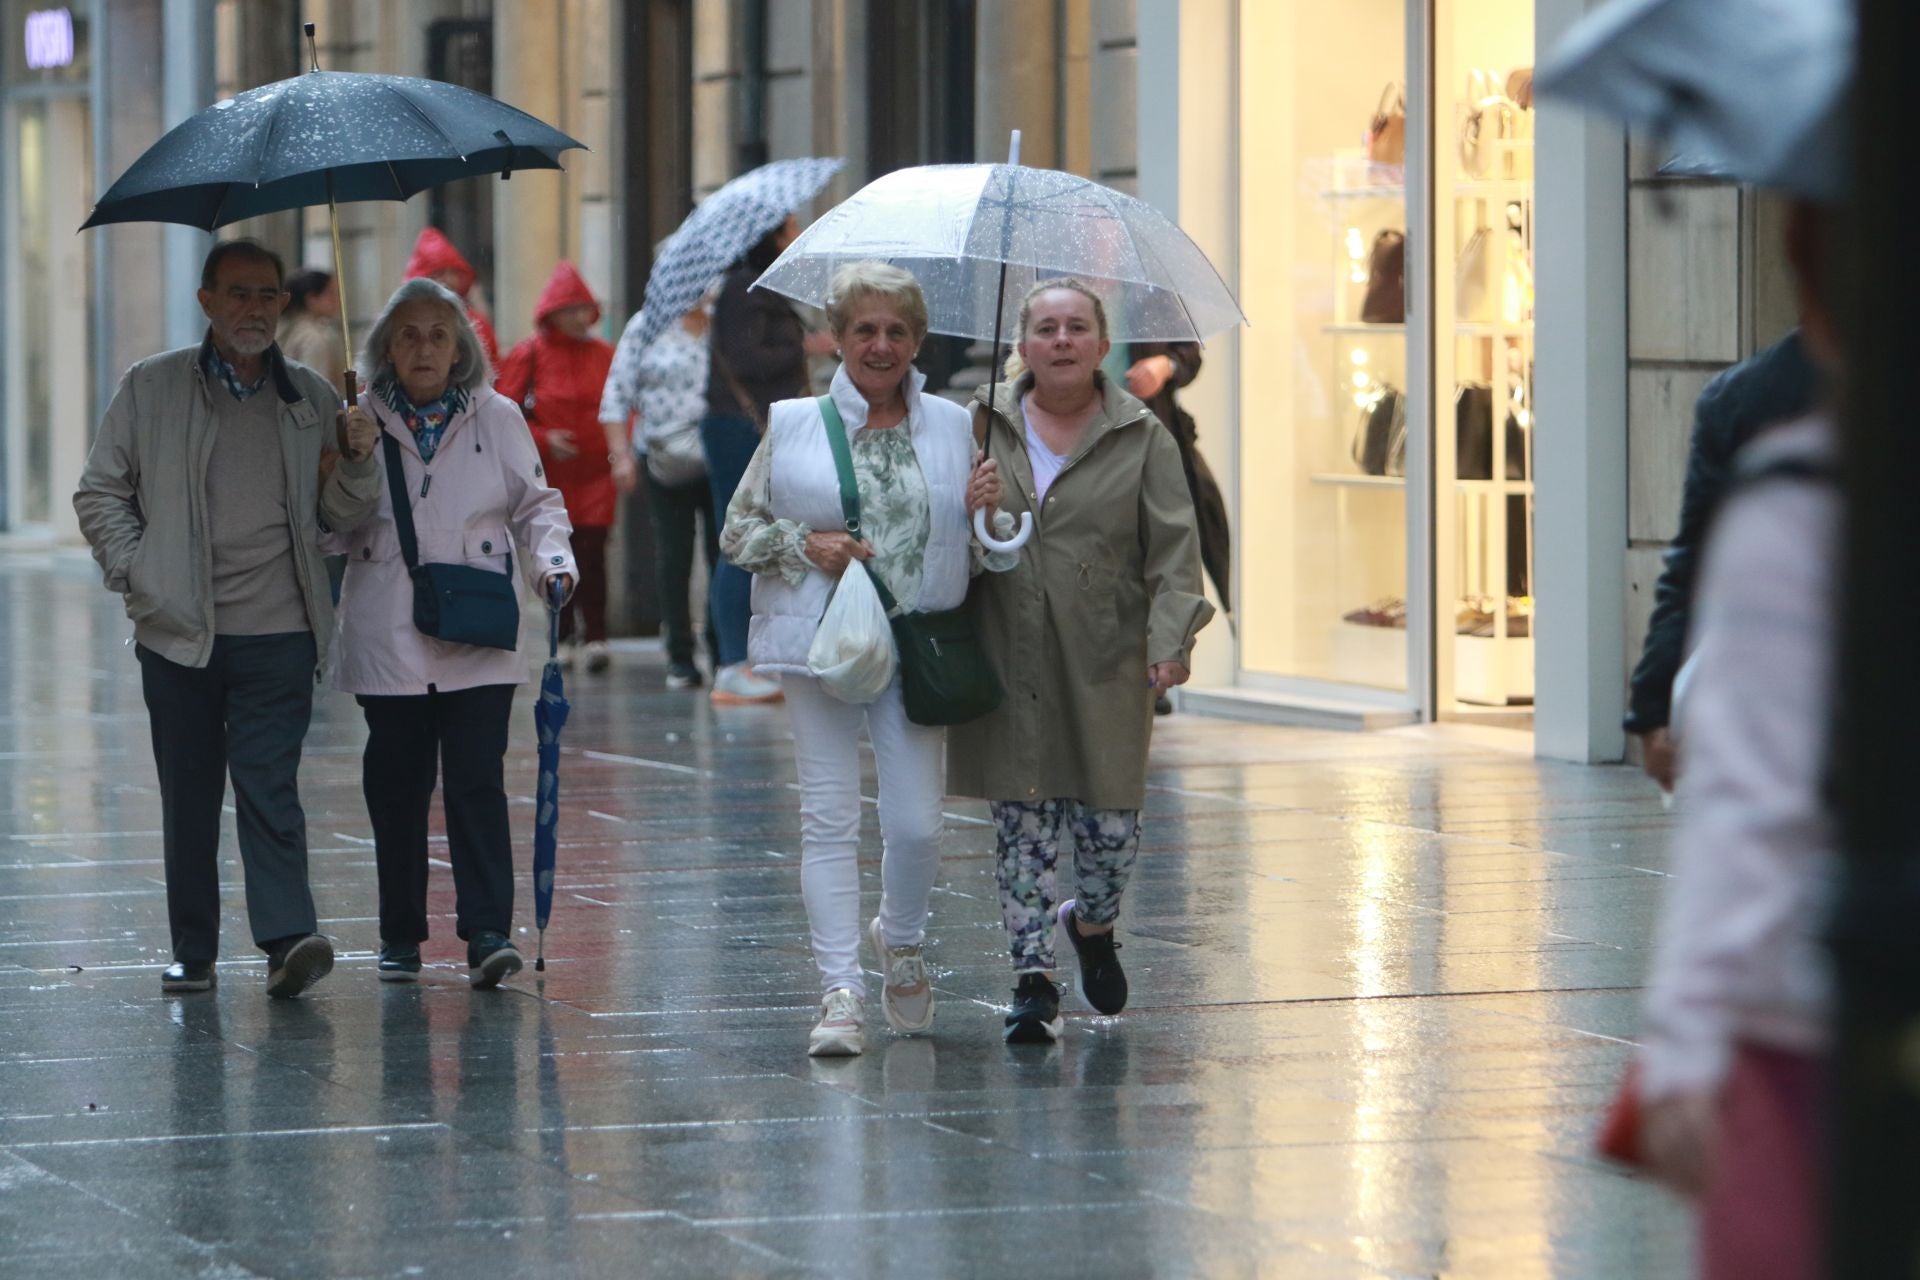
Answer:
[{"xmin": 73, "ymin": 240, "xmax": 380, "ymax": 998}]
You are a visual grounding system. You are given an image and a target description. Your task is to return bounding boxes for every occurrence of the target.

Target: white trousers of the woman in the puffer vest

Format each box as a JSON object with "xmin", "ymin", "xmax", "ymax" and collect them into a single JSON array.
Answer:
[{"xmin": 780, "ymin": 676, "xmax": 947, "ymax": 998}]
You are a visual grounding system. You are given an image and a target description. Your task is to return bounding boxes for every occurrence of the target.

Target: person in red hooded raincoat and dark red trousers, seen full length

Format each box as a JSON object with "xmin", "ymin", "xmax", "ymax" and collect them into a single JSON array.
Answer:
[{"xmin": 493, "ymin": 261, "xmax": 625, "ymax": 672}]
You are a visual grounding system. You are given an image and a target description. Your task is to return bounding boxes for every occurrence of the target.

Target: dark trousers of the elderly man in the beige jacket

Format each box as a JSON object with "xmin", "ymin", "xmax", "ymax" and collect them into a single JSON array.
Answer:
[{"xmin": 134, "ymin": 631, "xmax": 317, "ymax": 963}]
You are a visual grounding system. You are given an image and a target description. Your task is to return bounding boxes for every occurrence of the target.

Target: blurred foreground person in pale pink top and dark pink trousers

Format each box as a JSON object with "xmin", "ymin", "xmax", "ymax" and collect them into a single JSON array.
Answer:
[{"xmin": 1638, "ymin": 192, "xmax": 1841, "ymax": 1280}]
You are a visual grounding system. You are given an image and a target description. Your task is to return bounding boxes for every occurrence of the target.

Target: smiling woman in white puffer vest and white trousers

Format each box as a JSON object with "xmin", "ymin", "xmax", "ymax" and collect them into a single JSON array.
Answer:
[{"xmin": 720, "ymin": 263, "xmax": 1018, "ymax": 1057}]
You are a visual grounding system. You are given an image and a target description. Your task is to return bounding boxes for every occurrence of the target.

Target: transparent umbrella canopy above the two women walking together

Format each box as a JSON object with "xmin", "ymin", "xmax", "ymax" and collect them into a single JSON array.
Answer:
[{"xmin": 758, "ymin": 165, "xmax": 1246, "ymax": 342}]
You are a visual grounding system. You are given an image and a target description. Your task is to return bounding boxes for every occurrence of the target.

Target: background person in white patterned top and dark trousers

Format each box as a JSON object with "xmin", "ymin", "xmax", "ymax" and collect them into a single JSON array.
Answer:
[{"xmin": 599, "ymin": 299, "xmax": 720, "ymax": 689}]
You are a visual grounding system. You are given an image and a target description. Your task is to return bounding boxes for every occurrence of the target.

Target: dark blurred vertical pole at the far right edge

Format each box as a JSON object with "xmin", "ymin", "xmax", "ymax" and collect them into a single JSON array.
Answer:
[{"xmin": 1824, "ymin": 0, "xmax": 1920, "ymax": 1280}]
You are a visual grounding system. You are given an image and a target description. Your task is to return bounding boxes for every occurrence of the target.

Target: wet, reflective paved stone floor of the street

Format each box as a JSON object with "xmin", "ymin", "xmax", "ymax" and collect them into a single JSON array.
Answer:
[{"xmin": 0, "ymin": 551, "xmax": 1690, "ymax": 1280}]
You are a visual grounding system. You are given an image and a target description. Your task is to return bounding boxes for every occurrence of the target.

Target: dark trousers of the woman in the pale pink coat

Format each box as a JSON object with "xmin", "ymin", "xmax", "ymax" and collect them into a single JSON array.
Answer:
[{"xmin": 357, "ymin": 685, "xmax": 513, "ymax": 942}]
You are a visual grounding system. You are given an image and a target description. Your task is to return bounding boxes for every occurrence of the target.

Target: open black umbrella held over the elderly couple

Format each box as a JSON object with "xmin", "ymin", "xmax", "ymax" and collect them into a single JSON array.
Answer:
[{"xmin": 81, "ymin": 23, "xmax": 584, "ymax": 399}]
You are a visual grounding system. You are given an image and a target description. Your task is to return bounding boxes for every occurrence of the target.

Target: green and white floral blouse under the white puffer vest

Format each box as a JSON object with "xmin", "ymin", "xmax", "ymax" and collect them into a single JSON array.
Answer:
[{"xmin": 720, "ymin": 412, "xmax": 1020, "ymax": 612}]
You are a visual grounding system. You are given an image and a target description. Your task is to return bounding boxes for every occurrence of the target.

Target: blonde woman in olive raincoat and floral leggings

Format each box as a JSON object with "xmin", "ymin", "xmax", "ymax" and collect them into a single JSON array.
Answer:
[{"xmin": 947, "ymin": 280, "xmax": 1213, "ymax": 1044}]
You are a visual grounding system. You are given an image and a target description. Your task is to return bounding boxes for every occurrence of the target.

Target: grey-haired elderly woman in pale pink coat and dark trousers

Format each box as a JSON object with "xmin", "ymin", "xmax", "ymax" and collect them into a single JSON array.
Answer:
[{"xmin": 330, "ymin": 280, "xmax": 576, "ymax": 988}]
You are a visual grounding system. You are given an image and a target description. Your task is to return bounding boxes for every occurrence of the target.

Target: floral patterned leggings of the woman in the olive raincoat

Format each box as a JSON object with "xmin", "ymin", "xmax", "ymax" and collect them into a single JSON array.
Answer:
[{"xmin": 993, "ymin": 796, "xmax": 1140, "ymax": 973}]
